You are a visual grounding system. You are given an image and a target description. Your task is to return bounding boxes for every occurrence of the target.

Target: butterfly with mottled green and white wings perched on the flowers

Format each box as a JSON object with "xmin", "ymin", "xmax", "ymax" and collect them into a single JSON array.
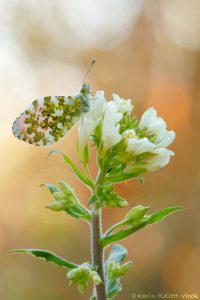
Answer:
[{"xmin": 12, "ymin": 60, "xmax": 95, "ymax": 146}]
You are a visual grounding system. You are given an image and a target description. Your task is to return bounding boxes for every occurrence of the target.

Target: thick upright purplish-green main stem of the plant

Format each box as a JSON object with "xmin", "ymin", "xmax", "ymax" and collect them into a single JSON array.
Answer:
[{"xmin": 91, "ymin": 173, "xmax": 108, "ymax": 300}]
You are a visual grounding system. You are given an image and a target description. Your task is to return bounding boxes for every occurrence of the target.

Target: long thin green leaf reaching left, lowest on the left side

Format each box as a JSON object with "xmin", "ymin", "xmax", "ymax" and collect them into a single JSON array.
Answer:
[{"xmin": 6, "ymin": 249, "xmax": 78, "ymax": 269}]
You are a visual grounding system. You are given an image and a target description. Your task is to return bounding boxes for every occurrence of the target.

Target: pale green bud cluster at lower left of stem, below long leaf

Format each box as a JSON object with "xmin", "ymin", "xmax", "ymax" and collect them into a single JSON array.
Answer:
[{"xmin": 67, "ymin": 264, "xmax": 101, "ymax": 293}]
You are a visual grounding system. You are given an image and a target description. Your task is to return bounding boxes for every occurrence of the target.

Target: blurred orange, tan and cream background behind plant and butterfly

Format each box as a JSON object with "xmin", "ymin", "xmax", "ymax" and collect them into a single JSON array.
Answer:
[{"xmin": 0, "ymin": 0, "xmax": 200, "ymax": 300}]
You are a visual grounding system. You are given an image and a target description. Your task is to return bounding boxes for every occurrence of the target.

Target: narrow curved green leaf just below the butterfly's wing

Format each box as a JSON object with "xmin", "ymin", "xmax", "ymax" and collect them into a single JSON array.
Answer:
[{"xmin": 48, "ymin": 149, "xmax": 94, "ymax": 190}]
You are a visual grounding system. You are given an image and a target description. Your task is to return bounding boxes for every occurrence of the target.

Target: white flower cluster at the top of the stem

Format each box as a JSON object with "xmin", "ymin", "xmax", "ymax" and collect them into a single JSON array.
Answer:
[{"xmin": 78, "ymin": 91, "xmax": 175, "ymax": 171}]
